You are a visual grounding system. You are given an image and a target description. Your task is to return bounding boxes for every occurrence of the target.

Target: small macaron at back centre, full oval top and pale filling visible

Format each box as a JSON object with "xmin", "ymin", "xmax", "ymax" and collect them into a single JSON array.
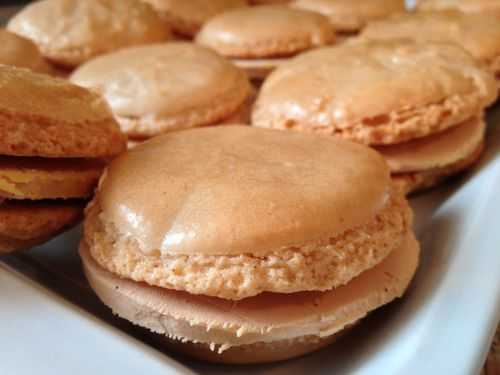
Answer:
[{"xmin": 196, "ymin": 5, "xmax": 335, "ymax": 79}]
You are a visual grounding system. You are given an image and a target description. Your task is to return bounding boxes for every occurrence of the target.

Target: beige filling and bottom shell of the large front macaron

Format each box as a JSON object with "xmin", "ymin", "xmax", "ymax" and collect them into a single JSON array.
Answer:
[{"xmin": 80, "ymin": 234, "xmax": 419, "ymax": 362}]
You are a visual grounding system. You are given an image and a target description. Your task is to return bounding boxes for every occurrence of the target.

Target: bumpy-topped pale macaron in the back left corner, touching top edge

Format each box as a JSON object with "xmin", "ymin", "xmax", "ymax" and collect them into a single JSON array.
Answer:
[{"xmin": 7, "ymin": 0, "xmax": 170, "ymax": 69}]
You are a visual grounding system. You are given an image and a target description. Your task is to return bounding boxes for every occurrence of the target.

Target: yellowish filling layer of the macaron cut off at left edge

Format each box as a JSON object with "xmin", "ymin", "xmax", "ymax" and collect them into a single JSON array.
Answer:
[{"xmin": 0, "ymin": 156, "xmax": 104, "ymax": 200}]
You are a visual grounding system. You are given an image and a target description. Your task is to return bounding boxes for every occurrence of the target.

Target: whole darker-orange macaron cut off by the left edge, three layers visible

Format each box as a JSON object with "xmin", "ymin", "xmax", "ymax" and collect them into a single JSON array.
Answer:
[{"xmin": 0, "ymin": 65, "xmax": 126, "ymax": 252}]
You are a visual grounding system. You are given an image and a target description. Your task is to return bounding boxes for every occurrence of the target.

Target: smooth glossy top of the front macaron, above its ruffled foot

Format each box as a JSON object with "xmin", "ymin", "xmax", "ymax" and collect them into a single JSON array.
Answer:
[{"xmin": 96, "ymin": 126, "xmax": 390, "ymax": 255}]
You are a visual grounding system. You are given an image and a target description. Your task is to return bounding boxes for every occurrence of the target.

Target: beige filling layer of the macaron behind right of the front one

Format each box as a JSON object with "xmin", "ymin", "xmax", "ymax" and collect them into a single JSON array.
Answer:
[{"xmin": 376, "ymin": 115, "xmax": 486, "ymax": 173}]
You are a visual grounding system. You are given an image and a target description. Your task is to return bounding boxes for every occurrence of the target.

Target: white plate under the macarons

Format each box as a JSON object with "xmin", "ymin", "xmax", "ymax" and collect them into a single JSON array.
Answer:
[{"xmin": 0, "ymin": 104, "xmax": 500, "ymax": 375}]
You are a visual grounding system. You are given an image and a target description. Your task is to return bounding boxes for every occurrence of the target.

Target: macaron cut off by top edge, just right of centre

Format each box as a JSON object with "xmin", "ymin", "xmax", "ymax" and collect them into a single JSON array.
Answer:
[{"xmin": 290, "ymin": 0, "xmax": 405, "ymax": 35}]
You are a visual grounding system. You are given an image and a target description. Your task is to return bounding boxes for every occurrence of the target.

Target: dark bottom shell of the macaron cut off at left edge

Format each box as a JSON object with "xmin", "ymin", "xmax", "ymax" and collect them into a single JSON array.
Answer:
[{"xmin": 0, "ymin": 200, "xmax": 85, "ymax": 254}]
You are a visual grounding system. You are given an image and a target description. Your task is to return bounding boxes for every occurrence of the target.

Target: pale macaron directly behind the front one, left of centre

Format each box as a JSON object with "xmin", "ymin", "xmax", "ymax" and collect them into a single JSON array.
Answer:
[{"xmin": 70, "ymin": 42, "xmax": 251, "ymax": 140}]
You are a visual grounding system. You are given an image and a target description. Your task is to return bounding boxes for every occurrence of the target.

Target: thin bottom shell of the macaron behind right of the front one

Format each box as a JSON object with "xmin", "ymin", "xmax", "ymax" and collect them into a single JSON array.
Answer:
[{"xmin": 392, "ymin": 142, "xmax": 485, "ymax": 195}]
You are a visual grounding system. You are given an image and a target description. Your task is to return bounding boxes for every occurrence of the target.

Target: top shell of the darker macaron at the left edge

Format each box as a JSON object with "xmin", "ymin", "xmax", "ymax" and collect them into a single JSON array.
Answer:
[{"xmin": 0, "ymin": 65, "xmax": 125, "ymax": 158}]
